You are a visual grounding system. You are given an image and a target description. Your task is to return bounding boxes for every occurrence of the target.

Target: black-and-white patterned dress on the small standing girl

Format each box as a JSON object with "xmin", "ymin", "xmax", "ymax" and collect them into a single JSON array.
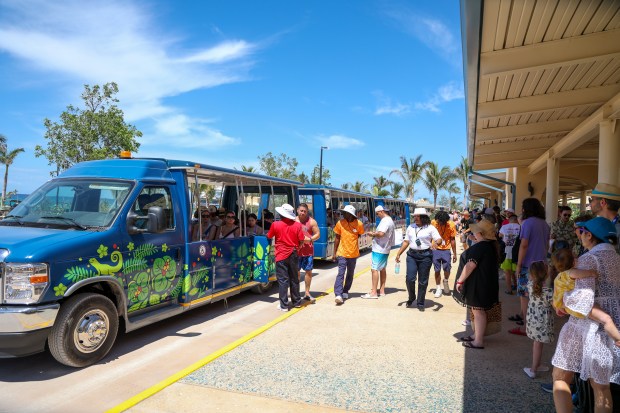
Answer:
[{"xmin": 525, "ymin": 281, "xmax": 555, "ymax": 343}]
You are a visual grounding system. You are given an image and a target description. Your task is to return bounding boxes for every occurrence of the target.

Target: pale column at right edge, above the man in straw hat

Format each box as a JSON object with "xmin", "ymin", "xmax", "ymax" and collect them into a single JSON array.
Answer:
[{"xmin": 598, "ymin": 119, "xmax": 620, "ymax": 185}]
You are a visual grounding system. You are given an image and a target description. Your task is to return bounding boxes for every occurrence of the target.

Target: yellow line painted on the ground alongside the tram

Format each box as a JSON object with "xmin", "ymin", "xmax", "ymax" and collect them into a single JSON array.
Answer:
[{"xmin": 106, "ymin": 260, "xmax": 370, "ymax": 413}]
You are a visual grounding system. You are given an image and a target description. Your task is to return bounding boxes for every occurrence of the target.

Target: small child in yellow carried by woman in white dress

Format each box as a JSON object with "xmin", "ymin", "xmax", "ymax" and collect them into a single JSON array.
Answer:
[{"xmin": 551, "ymin": 248, "xmax": 620, "ymax": 346}]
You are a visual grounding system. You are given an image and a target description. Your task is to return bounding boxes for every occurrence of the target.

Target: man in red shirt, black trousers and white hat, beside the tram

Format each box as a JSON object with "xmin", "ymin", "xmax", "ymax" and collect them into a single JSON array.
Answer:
[{"xmin": 267, "ymin": 204, "xmax": 304, "ymax": 312}]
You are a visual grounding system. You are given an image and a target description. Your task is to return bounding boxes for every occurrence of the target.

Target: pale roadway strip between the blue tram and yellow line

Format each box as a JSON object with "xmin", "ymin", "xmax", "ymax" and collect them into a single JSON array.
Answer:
[{"xmin": 0, "ymin": 262, "xmax": 342, "ymax": 413}]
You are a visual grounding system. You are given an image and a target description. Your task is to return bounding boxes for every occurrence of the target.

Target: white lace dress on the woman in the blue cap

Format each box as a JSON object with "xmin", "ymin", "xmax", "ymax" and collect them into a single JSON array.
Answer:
[{"xmin": 551, "ymin": 244, "xmax": 620, "ymax": 384}]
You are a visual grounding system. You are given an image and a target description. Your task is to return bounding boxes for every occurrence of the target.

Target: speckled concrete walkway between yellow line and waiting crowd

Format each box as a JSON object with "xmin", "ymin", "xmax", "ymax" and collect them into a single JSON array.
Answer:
[{"xmin": 129, "ymin": 246, "xmax": 559, "ymax": 413}]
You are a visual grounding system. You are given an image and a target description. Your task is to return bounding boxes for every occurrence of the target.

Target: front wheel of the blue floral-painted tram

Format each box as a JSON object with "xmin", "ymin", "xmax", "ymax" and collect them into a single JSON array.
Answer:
[{"xmin": 48, "ymin": 293, "xmax": 119, "ymax": 367}]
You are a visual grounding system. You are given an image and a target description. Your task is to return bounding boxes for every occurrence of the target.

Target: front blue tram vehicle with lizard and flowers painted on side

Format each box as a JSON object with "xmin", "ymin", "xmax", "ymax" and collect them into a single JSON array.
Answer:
[{"xmin": 0, "ymin": 154, "xmax": 299, "ymax": 367}]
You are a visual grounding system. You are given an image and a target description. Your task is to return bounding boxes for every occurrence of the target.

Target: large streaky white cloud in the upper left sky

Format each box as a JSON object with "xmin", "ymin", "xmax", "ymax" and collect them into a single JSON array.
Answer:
[{"xmin": 0, "ymin": 0, "xmax": 258, "ymax": 147}]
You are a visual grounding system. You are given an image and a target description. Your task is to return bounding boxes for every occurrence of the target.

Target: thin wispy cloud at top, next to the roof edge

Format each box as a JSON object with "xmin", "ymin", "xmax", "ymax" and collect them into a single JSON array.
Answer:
[{"xmin": 385, "ymin": 8, "xmax": 462, "ymax": 67}]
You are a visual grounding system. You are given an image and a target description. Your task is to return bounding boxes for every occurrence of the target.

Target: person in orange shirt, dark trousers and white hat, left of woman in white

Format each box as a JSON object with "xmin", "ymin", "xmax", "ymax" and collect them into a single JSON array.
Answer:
[{"xmin": 334, "ymin": 205, "xmax": 364, "ymax": 305}]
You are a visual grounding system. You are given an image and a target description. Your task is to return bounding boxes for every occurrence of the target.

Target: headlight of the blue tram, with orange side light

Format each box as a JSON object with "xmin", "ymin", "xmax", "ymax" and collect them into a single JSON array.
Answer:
[{"xmin": 3, "ymin": 263, "xmax": 49, "ymax": 304}]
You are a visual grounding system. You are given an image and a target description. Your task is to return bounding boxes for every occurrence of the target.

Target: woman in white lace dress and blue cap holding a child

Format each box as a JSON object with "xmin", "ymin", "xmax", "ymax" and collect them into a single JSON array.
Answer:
[{"xmin": 551, "ymin": 217, "xmax": 620, "ymax": 413}]
